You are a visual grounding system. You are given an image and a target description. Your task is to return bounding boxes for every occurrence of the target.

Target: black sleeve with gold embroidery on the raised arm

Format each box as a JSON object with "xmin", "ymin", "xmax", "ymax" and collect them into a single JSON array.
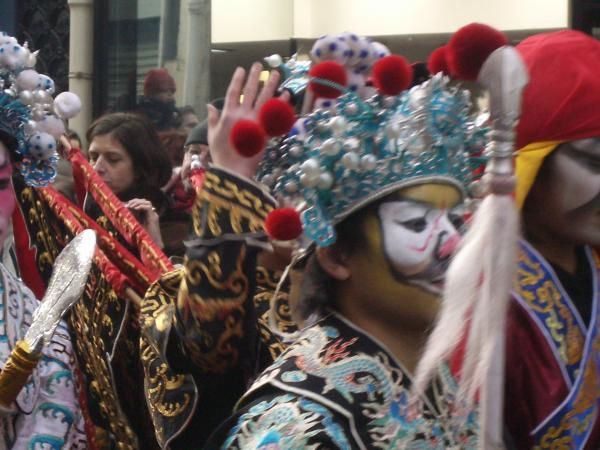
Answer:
[{"xmin": 174, "ymin": 168, "xmax": 275, "ymax": 374}]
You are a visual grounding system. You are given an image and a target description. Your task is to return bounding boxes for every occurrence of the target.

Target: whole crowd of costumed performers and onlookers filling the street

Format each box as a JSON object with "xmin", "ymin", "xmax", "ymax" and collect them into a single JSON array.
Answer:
[{"xmin": 0, "ymin": 20, "xmax": 600, "ymax": 450}]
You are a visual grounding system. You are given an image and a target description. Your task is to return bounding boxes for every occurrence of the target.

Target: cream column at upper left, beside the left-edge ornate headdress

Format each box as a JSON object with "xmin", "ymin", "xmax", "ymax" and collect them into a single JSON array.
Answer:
[{"xmin": 68, "ymin": 0, "xmax": 94, "ymax": 145}]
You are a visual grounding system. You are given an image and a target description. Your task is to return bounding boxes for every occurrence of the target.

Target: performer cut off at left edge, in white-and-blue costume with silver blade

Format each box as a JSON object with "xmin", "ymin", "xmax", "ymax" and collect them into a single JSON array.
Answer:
[{"xmin": 0, "ymin": 34, "xmax": 95, "ymax": 449}]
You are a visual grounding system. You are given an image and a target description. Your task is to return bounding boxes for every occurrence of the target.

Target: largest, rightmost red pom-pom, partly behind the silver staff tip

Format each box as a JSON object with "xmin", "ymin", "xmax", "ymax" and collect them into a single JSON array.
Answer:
[{"xmin": 446, "ymin": 23, "xmax": 508, "ymax": 81}]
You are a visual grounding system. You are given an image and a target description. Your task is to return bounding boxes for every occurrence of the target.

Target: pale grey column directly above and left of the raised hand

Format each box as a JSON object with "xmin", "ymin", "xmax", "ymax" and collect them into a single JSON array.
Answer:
[{"xmin": 183, "ymin": 0, "xmax": 211, "ymax": 118}]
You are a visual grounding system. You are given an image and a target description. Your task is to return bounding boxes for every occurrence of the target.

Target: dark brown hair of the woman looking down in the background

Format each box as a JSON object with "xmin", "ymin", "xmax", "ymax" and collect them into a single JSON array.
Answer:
[{"xmin": 86, "ymin": 113, "xmax": 172, "ymax": 193}]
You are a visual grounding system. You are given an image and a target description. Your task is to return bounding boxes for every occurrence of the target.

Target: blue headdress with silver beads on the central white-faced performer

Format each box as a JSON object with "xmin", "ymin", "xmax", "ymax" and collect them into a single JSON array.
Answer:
[{"xmin": 258, "ymin": 73, "xmax": 486, "ymax": 246}]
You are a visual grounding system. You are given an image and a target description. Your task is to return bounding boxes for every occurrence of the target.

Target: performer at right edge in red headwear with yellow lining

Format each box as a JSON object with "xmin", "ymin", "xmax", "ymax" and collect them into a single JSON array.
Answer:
[{"xmin": 506, "ymin": 31, "xmax": 600, "ymax": 449}]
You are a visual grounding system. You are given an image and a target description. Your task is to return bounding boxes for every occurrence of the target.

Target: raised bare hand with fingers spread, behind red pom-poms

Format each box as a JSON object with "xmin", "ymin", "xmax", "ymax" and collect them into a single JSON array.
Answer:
[{"xmin": 208, "ymin": 63, "xmax": 286, "ymax": 178}]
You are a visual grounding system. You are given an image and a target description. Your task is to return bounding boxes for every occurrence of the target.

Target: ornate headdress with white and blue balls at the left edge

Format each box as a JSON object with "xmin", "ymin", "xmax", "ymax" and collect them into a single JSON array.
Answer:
[{"xmin": 0, "ymin": 33, "xmax": 81, "ymax": 187}]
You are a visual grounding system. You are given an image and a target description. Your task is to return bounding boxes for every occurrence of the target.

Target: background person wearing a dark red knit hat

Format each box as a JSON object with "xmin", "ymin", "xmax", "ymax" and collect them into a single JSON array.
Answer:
[{"xmin": 136, "ymin": 69, "xmax": 181, "ymax": 131}]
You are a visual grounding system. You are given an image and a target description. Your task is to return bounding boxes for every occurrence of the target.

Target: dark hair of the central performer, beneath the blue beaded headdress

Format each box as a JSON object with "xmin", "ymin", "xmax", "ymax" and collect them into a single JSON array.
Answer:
[{"xmin": 295, "ymin": 201, "xmax": 381, "ymax": 320}]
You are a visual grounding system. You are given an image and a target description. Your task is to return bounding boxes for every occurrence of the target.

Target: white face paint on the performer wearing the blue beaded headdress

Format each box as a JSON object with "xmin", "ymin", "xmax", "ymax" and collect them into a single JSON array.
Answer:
[{"xmin": 379, "ymin": 200, "xmax": 462, "ymax": 293}]
